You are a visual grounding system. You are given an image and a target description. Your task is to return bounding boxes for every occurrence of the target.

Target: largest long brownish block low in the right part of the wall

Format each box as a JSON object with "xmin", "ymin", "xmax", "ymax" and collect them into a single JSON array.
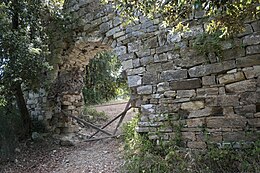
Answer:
[{"xmin": 206, "ymin": 115, "xmax": 247, "ymax": 129}]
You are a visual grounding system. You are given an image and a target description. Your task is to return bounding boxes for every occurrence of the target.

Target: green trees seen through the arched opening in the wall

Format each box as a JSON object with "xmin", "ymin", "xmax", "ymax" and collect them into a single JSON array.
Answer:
[{"xmin": 83, "ymin": 52, "xmax": 128, "ymax": 104}]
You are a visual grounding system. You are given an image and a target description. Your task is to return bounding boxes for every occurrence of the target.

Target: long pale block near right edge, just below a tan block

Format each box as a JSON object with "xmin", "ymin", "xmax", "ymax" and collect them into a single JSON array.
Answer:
[{"xmin": 226, "ymin": 80, "xmax": 256, "ymax": 93}]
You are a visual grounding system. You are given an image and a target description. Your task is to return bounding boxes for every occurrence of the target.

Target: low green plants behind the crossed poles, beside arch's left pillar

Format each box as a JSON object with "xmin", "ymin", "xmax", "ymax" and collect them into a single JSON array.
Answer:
[{"xmin": 81, "ymin": 106, "xmax": 108, "ymax": 123}]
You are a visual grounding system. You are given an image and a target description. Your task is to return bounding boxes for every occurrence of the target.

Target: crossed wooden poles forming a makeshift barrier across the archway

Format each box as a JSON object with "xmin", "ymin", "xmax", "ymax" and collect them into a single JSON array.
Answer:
[{"xmin": 62, "ymin": 96, "xmax": 133, "ymax": 142}]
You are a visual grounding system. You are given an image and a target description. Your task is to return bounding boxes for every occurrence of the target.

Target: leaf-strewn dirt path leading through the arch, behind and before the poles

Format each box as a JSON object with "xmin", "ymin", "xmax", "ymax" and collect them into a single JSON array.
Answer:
[{"xmin": 0, "ymin": 103, "xmax": 136, "ymax": 173}]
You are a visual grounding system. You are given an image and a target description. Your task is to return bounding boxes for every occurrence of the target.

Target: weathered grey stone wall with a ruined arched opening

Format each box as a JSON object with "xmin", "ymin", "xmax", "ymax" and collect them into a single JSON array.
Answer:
[{"xmin": 24, "ymin": 0, "xmax": 260, "ymax": 148}]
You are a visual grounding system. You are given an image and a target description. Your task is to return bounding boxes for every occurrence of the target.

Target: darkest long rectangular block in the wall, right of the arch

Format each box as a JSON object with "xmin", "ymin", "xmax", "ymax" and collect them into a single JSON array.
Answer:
[{"xmin": 170, "ymin": 78, "xmax": 201, "ymax": 90}]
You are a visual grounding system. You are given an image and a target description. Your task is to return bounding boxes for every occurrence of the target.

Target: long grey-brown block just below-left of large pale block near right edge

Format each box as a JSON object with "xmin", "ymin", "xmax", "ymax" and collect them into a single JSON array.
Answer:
[{"xmin": 206, "ymin": 95, "xmax": 239, "ymax": 106}]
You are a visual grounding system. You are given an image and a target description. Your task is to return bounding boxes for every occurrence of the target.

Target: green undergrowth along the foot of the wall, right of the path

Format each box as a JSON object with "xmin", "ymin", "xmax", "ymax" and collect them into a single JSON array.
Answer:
[{"xmin": 122, "ymin": 116, "xmax": 260, "ymax": 173}]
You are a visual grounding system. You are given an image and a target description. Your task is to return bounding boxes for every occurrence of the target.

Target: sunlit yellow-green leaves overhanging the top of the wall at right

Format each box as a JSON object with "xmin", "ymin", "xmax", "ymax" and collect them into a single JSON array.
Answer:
[{"xmin": 108, "ymin": 0, "xmax": 260, "ymax": 36}]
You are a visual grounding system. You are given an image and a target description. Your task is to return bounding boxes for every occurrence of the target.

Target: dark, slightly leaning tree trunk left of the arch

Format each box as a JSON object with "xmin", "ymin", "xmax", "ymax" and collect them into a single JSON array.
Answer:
[{"xmin": 15, "ymin": 83, "xmax": 32, "ymax": 139}]
